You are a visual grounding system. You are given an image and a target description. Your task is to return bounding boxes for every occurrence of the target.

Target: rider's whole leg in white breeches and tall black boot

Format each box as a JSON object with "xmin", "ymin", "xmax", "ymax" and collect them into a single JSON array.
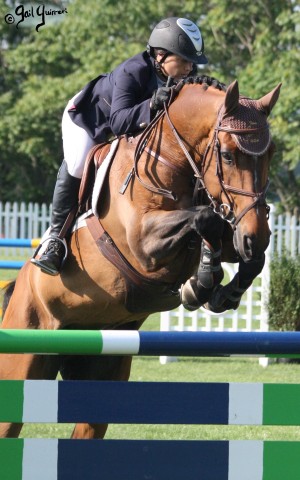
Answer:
[{"xmin": 31, "ymin": 94, "xmax": 95, "ymax": 275}]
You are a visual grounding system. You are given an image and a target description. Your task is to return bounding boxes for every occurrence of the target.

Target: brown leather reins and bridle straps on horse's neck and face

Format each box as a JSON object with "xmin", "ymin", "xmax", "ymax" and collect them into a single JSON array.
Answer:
[{"xmin": 132, "ymin": 82, "xmax": 270, "ymax": 230}]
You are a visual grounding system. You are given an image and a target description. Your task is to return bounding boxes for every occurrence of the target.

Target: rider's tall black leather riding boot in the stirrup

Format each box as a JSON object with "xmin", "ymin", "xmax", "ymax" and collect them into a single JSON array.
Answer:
[{"xmin": 31, "ymin": 161, "xmax": 81, "ymax": 275}]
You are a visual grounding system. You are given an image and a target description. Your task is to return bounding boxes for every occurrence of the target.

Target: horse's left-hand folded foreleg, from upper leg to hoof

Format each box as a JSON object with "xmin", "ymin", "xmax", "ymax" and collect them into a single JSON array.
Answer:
[{"xmin": 132, "ymin": 206, "xmax": 225, "ymax": 310}]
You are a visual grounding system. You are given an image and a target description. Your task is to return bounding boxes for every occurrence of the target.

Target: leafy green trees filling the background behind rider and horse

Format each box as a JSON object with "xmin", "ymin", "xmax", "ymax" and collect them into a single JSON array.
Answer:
[{"xmin": 0, "ymin": 0, "xmax": 300, "ymax": 204}]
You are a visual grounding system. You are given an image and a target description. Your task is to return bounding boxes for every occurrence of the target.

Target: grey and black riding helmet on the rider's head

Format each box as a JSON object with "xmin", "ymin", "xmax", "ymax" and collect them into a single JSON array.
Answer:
[{"xmin": 148, "ymin": 17, "xmax": 207, "ymax": 65}]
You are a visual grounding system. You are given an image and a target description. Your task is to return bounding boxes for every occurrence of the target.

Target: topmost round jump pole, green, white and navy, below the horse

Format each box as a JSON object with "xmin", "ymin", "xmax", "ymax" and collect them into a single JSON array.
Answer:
[{"xmin": 0, "ymin": 329, "xmax": 300, "ymax": 358}]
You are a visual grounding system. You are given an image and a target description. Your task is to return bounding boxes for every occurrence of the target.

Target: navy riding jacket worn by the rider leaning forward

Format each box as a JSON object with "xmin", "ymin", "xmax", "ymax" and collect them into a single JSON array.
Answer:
[{"xmin": 69, "ymin": 51, "xmax": 162, "ymax": 143}]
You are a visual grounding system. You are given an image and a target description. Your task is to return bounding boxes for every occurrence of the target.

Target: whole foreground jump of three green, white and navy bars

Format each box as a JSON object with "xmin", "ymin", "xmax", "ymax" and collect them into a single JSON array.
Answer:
[{"xmin": 0, "ymin": 330, "xmax": 300, "ymax": 480}]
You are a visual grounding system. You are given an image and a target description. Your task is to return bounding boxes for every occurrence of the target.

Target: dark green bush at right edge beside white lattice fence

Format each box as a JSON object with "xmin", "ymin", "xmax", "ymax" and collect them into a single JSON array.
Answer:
[{"xmin": 268, "ymin": 255, "xmax": 300, "ymax": 330}]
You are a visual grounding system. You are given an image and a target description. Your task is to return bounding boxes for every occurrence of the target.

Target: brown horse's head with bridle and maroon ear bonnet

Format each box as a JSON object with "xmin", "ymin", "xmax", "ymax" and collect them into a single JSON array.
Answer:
[{"xmin": 203, "ymin": 81, "xmax": 281, "ymax": 262}]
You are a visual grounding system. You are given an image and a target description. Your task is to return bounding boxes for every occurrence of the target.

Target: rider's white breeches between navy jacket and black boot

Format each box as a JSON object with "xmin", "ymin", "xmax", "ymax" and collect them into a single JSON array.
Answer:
[{"xmin": 62, "ymin": 92, "xmax": 96, "ymax": 178}]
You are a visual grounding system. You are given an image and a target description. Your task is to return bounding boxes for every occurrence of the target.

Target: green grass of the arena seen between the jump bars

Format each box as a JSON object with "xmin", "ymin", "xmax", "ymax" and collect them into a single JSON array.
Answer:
[{"xmin": 0, "ymin": 262, "xmax": 300, "ymax": 441}]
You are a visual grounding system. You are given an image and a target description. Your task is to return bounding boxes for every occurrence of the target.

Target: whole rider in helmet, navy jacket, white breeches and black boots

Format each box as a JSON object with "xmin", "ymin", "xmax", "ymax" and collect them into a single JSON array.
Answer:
[{"xmin": 31, "ymin": 17, "xmax": 207, "ymax": 275}]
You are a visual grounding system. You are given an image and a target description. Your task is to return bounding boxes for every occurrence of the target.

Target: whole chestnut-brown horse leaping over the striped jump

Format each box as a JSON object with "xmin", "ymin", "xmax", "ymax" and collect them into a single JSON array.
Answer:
[{"xmin": 0, "ymin": 77, "xmax": 280, "ymax": 438}]
